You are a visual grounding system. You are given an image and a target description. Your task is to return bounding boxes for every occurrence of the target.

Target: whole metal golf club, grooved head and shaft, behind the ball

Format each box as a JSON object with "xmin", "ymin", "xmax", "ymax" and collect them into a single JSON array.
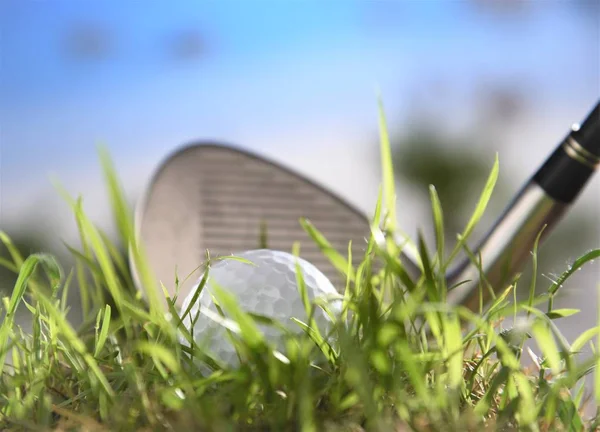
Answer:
[{"xmin": 131, "ymin": 103, "xmax": 600, "ymax": 310}]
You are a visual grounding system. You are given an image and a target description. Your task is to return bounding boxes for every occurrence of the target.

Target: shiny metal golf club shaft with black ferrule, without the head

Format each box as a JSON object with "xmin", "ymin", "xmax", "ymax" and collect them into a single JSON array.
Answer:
[{"xmin": 412, "ymin": 103, "xmax": 600, "ymax": 311}]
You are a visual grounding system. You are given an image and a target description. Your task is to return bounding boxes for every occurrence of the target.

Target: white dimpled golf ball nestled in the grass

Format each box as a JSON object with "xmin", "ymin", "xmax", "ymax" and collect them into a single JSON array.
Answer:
[{"xmin": 182, "ymin": 249, "xmax": 341, "ymax": 364}]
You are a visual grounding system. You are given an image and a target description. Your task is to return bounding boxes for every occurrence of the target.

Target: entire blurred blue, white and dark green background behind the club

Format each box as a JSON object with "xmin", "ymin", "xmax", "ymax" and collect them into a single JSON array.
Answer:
[{"xmin": 0, "ymin": 0, "xmax": 600, "ymax": 354}]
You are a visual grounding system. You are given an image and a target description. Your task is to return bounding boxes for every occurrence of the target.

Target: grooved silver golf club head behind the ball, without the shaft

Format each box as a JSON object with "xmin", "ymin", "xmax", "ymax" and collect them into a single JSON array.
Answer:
[{"xmin": 132, "ymin": 142, "xmax": 382, "ymax": 306}]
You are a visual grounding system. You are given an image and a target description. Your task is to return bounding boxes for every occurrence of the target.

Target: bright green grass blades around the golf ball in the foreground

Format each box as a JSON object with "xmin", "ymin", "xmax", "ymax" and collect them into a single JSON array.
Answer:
[{"xmin": 0, "ymin": 102, "xmax": 600, "ymax": 432}]
